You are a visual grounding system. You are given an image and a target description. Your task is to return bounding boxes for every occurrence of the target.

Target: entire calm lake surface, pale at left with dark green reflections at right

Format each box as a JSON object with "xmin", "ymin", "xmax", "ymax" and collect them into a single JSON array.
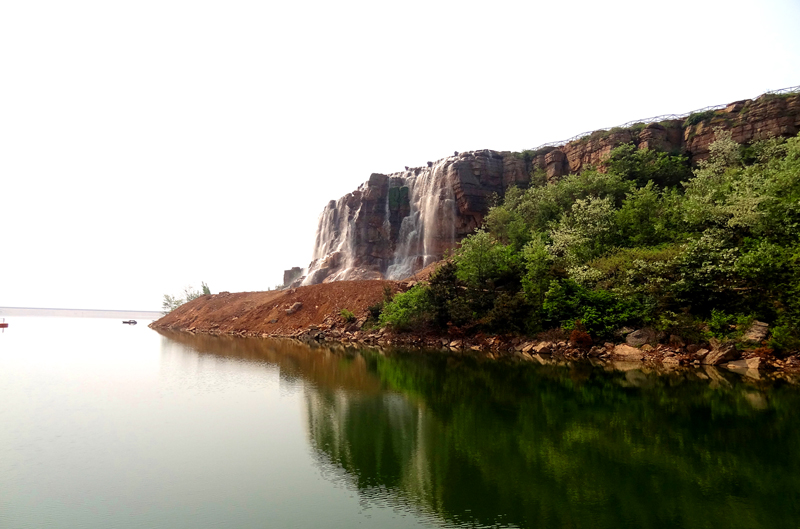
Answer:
[{"xmin": 0, "ymin": 318, "xmax": 800, "ymax": 529}]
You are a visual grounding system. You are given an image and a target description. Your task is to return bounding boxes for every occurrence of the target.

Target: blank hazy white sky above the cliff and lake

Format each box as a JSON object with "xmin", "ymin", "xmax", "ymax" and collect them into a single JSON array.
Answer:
[{"xmin": 0, "ymin": 0, "xmax": 800, "ymax": 310}]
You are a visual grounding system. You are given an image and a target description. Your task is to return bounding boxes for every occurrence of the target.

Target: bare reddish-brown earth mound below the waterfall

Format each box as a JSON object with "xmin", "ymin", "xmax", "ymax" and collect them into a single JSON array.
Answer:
[{"xmin": 151, "ymin": 281, "xmax": 405, "ymax": 336}]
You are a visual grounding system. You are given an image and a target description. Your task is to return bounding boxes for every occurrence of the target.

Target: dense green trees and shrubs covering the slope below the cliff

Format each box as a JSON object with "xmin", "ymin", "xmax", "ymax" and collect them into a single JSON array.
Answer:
[{"xmin": 380, "ymin": 130, "xmax": 800, "ymax": 350}]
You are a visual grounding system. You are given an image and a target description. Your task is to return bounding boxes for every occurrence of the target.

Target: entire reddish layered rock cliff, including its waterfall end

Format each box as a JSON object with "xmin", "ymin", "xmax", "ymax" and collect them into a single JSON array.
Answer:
[{"xmin": 296, "ymin": 91, "xmax": 800, "ymax": 285}]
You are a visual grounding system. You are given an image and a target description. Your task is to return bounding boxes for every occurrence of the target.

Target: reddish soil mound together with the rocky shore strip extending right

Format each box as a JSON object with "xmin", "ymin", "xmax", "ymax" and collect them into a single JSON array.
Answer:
[{"xmin": 150, "ymin": 281, "xmax": 800, "ymax": 382}]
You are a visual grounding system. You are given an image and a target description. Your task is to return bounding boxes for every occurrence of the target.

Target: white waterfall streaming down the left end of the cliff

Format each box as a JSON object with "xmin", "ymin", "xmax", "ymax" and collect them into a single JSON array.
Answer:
[{"xmin": 303, "ymin": 159, "xmax": 457, "ymax": 285}]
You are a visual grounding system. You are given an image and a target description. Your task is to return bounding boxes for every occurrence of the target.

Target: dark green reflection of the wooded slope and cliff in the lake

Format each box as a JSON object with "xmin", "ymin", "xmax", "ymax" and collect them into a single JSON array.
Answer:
[{"xmin": 156, "ymin": 330, "xmax": 800, "ymax": 528}]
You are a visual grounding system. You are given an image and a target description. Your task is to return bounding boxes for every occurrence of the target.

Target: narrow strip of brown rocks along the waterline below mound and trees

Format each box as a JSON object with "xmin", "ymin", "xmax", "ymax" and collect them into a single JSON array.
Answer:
[{"xmin": 150, "ymin": 308, "xmax": 800, "ymax": 384}]
